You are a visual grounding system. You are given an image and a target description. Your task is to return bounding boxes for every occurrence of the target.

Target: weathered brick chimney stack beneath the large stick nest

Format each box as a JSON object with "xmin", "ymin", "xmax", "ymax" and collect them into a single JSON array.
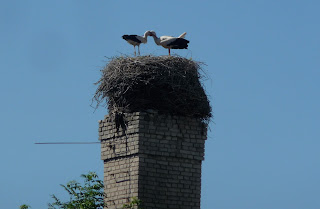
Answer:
[{"xmin": 99, "ymin": 111, "xmax": 207, "ymax": 209}]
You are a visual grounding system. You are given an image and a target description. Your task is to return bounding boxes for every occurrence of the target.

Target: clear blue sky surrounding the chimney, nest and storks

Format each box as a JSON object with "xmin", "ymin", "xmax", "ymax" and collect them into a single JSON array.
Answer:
[{"xmin": 0, "ymin": 0, "xmax": 320, "ymax": 209}]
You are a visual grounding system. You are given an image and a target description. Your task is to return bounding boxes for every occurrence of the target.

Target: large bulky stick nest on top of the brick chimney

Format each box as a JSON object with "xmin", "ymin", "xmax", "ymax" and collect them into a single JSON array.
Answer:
[{"xmin": 93, "ymin": 56, "xmax": 212, "ymax": 121}]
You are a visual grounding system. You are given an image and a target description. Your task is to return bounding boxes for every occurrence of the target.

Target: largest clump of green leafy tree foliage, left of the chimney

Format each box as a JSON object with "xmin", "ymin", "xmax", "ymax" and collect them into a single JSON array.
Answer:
[{"xmin": 48, "ymin": 172, "xmax": 104, "ymax": 209}]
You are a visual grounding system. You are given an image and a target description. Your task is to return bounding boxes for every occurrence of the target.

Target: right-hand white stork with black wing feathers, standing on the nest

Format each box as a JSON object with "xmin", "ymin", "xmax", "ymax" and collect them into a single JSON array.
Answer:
[{"xmin": 150, "ymin": 31, "xmax": 189, "ymax": 56}]
